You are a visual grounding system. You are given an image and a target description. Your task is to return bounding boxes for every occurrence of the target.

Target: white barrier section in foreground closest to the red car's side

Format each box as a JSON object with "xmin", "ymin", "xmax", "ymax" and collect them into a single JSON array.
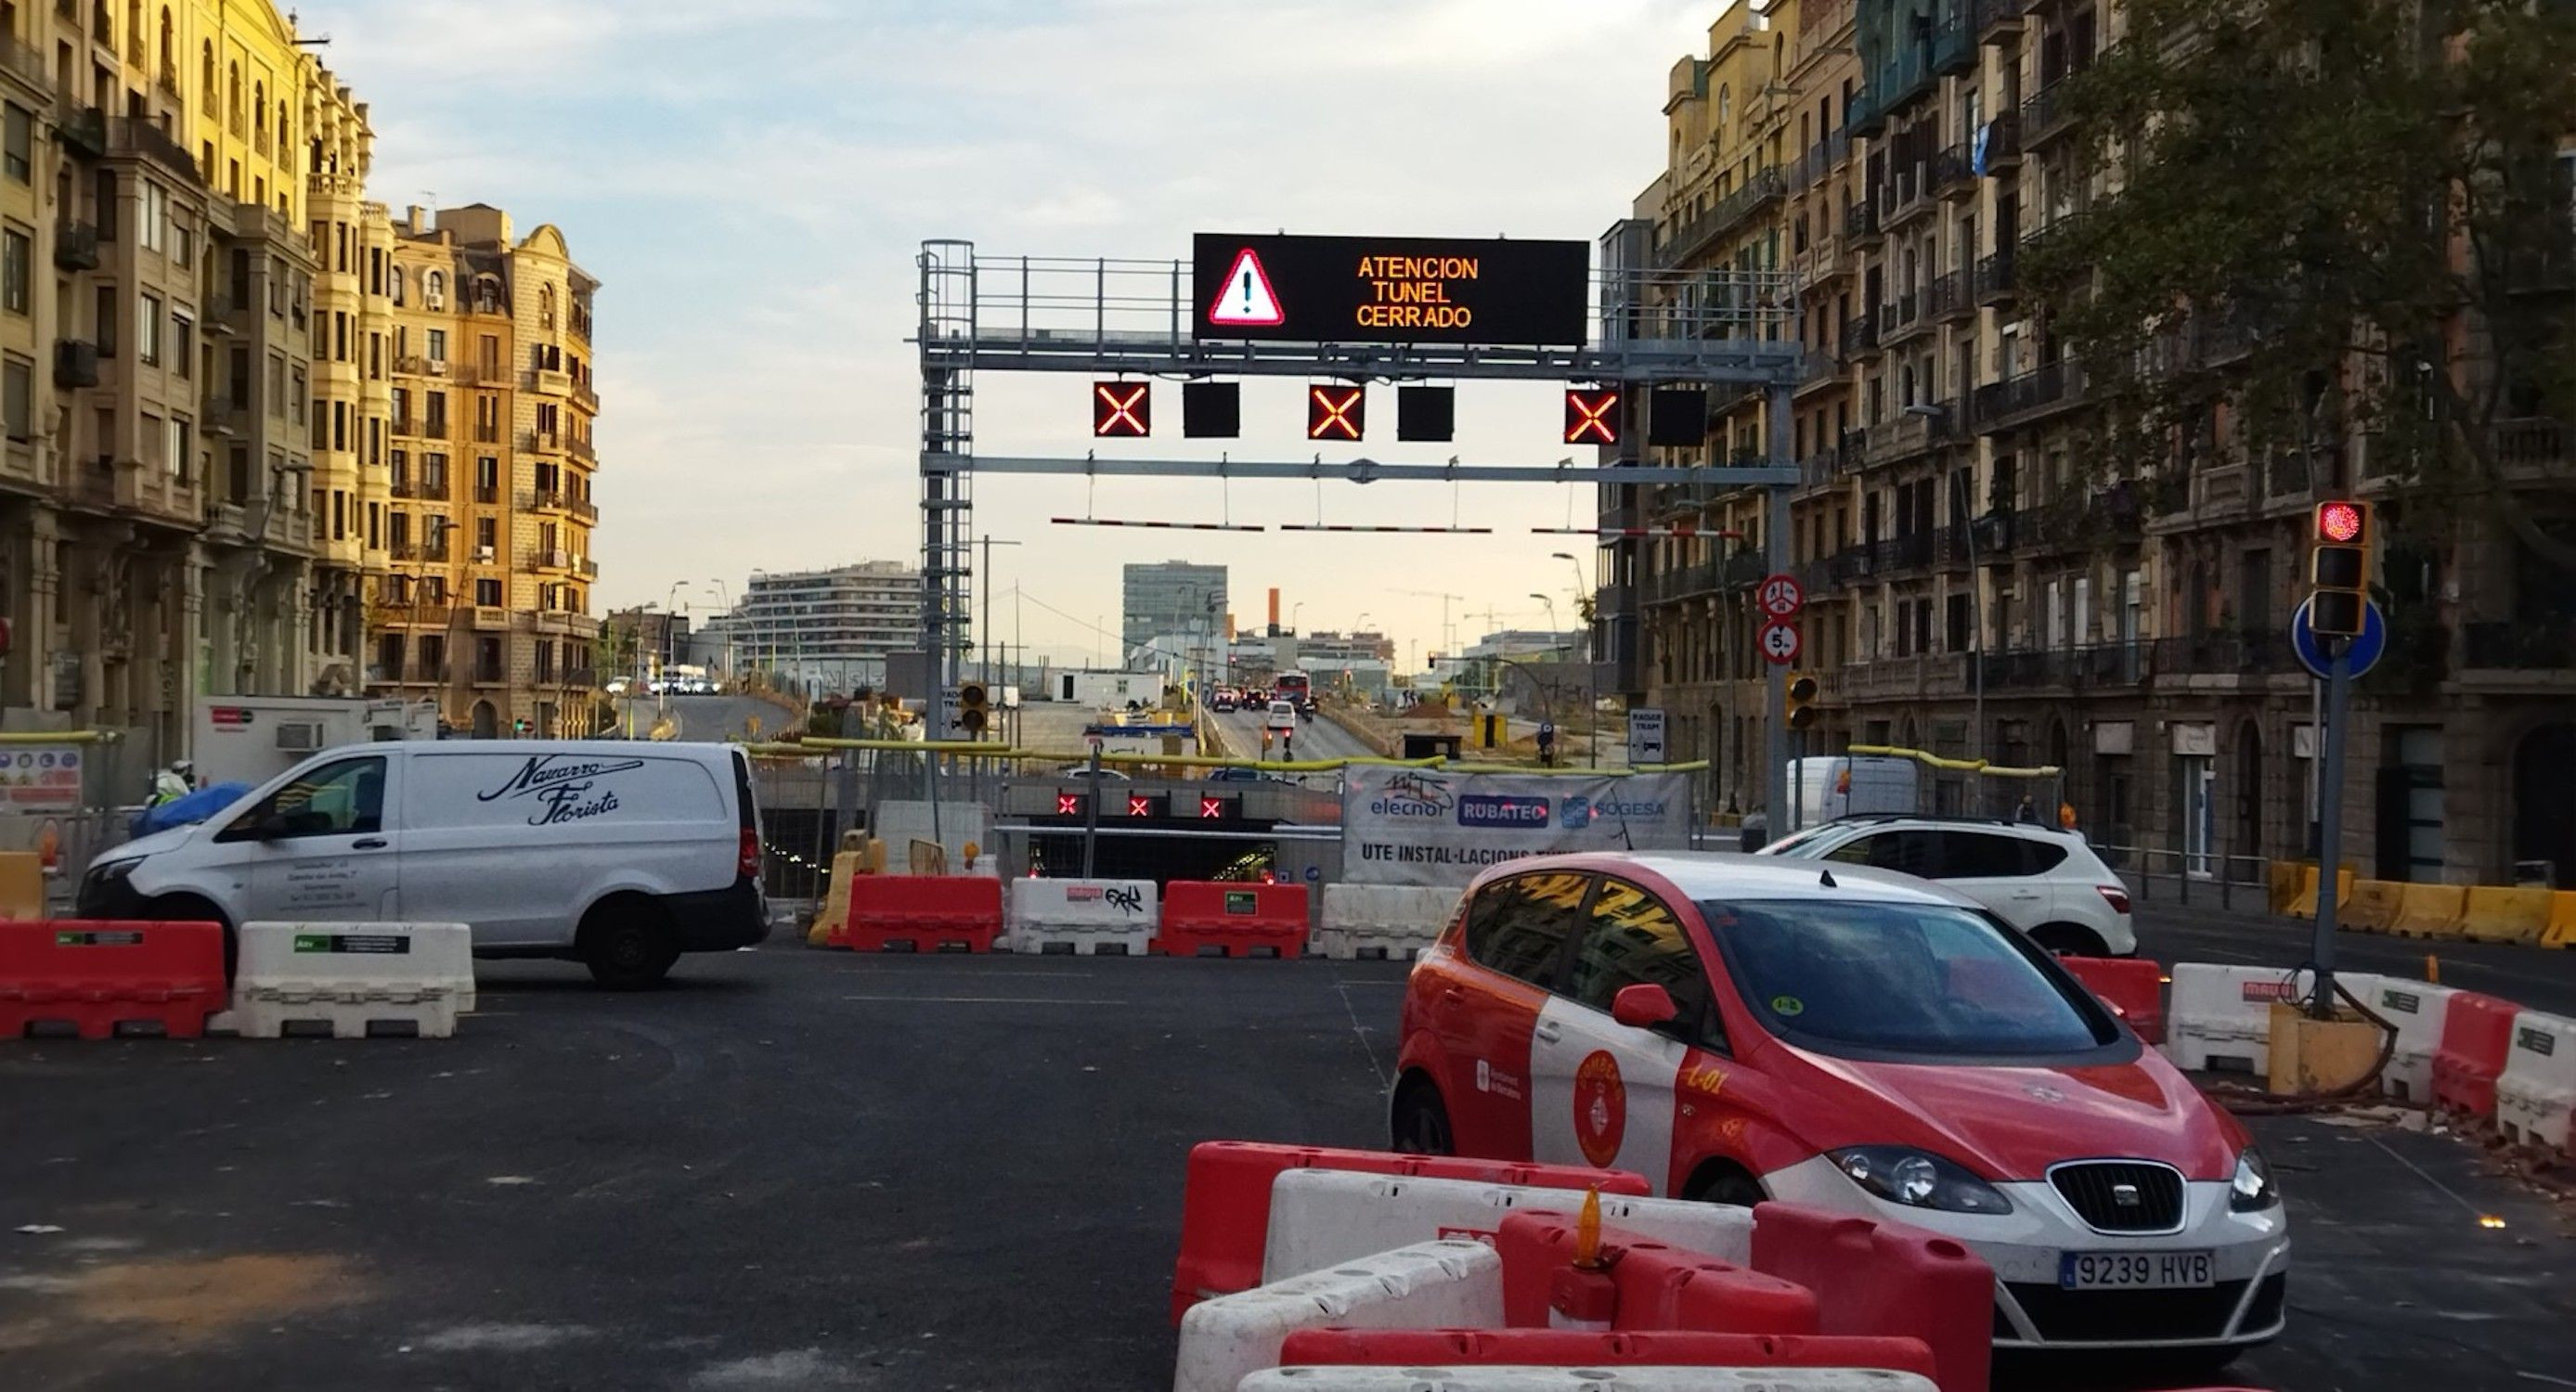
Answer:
[{"xmin": 1262, "ymin": 1171, "xmax": 1754, "ymax": 1282}]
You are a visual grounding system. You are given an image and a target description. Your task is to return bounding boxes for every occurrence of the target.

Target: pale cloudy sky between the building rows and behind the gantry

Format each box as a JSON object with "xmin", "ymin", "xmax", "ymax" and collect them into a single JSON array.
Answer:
[{"xmin": 321, "ymin": 0, "xmax": 1726, "ymax": 662}]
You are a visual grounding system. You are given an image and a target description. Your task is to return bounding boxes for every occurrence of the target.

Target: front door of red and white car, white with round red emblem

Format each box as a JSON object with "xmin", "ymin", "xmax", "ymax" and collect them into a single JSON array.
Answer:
[{"xmin": 1530, "ymin": 875, "xmax": 1708, "ymax": 1192}]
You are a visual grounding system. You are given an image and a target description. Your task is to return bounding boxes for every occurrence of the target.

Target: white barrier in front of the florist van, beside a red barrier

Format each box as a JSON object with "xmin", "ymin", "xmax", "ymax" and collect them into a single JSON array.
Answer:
[{"xmin": 224, "ymin": 923, "xmax": 474, "ymax": 1039}]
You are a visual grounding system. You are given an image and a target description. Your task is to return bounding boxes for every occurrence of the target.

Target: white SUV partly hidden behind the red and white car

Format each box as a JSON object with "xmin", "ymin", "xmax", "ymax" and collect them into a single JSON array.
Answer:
[{"xmin": 1762, "ymin": 816, "xmax": 2138, "ymax": 957}]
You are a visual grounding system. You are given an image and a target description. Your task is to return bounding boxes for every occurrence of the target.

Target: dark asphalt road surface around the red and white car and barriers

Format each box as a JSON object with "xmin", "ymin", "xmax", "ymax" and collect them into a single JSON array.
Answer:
[{"xmin": 0, "ymin": 945, "xmax": 2576, "ymax": 1392}]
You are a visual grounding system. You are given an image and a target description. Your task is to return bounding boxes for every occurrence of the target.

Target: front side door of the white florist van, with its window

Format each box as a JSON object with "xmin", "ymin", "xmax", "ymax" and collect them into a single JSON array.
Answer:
[{"xmin": 216, "ymin": 754, "xmax": 402, "ymax": 923}]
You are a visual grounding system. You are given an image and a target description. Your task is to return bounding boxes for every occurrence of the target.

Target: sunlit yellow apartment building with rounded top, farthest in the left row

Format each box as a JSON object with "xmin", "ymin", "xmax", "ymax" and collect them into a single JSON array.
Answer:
[{"xmin": 368, "ymin": 203, "xmax": 605, "ymax": 739}]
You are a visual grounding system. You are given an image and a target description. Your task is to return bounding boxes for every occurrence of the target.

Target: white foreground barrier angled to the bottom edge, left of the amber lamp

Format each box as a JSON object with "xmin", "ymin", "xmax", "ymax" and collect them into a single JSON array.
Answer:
[{"xmin": 1172, "ymin": 1243, "xmax": 1502, "ymax": 1392}]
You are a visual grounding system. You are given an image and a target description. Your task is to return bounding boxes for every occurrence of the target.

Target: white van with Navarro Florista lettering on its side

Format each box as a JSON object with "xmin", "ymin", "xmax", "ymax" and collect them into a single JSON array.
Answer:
[{"xmin": 80, "ymin": 741, "xmax": 770, "ymax": 988}]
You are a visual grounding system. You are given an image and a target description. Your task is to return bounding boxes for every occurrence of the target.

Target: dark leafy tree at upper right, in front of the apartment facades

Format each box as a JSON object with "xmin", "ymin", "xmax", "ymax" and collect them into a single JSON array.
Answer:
[{"xmin": 2022, "ymin": 0, "xmax": 2576, "ymax": 572}]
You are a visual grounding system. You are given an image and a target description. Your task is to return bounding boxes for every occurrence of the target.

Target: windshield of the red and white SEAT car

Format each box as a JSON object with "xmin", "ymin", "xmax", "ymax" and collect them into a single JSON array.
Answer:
[{"xmin": 1701, "ymin": 900, "xmax": 2117, "ymax": 1060}]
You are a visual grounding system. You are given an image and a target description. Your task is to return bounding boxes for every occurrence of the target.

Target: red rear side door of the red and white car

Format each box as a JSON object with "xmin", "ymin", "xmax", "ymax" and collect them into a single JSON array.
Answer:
[{"xmin": 1427, "ymin": 870, "xmax": 1592, "ymax": 1160}]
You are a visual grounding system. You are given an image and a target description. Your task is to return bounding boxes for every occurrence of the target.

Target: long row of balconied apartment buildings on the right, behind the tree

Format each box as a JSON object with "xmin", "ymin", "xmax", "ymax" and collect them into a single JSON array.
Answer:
[{"xmin": 1599, "ymin": 0, "xmax": 2576, "ymax": 885}]
